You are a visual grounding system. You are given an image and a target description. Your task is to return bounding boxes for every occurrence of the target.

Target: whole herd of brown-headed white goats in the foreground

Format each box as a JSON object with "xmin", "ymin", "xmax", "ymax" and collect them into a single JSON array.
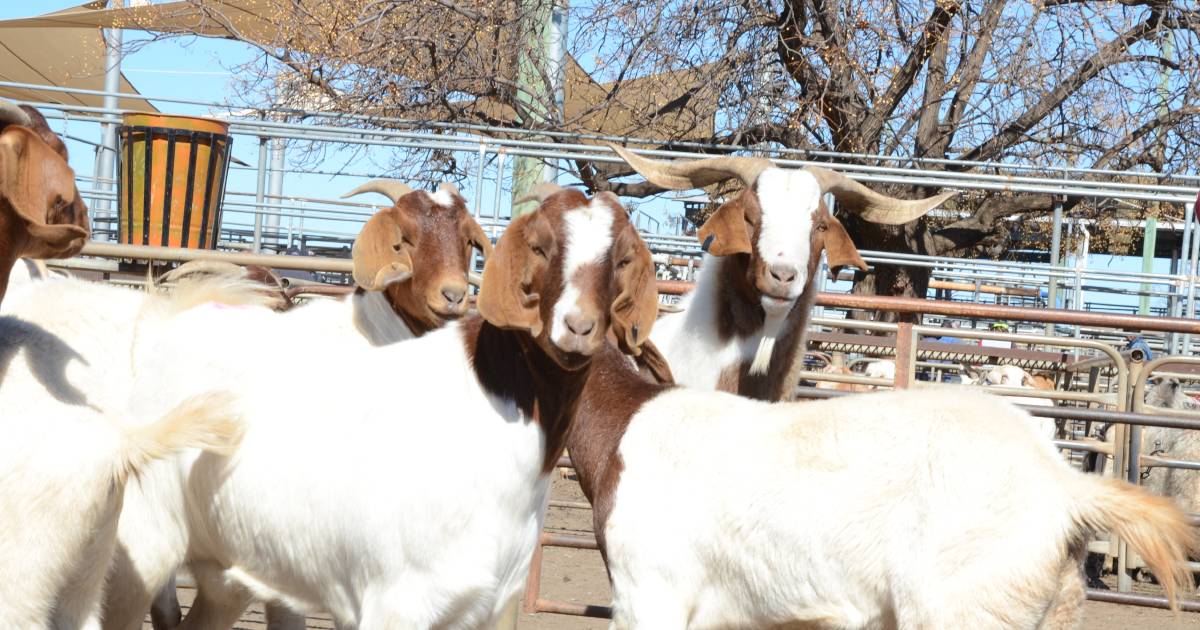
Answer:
[{"xmin": 0, "ymin": 104, "xmax": 1200, "ymax": 630}]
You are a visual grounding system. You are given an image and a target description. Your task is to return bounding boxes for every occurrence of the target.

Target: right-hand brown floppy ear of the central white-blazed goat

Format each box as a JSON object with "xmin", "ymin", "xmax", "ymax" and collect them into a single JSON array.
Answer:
[{"xmin": 610, "ymin": 223, "xmax": 659, "ymax": 356}]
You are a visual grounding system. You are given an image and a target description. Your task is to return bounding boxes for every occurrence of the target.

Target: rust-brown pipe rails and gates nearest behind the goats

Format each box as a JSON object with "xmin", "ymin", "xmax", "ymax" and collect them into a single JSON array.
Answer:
[{"xmin": 32, "ymin": 244, "xmax": 1200, "ymax": 617}]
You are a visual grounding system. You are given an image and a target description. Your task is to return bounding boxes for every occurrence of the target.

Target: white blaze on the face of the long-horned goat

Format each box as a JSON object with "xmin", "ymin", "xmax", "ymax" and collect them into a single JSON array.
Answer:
[{"xmin": 756, "ymin": 168, "xmax": 821, "ymax": 300}]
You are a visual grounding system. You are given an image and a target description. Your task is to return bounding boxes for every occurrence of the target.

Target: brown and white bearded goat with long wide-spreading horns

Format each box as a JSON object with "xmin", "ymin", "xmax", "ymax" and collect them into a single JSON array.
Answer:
[{"xmin": 612, "ymin": 146, "xmax": 954, "ymax": 401}]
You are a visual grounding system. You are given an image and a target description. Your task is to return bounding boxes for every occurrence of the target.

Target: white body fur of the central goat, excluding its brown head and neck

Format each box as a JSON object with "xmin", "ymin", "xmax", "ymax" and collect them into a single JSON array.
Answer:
[{"xmin": 106, "ymin": 308, "xmax": 548, "ymax": 628}]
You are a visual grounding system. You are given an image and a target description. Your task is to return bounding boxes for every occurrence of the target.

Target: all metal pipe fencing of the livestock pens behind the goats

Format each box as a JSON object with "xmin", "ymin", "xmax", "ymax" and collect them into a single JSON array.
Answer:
[{"xmin": 7, "ymin": 81, "xmax": 1200, "ymax": 617}]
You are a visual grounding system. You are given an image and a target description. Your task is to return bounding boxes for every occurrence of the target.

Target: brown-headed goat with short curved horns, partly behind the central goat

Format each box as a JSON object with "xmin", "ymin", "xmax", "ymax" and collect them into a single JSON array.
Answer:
[{"xmin": 98, "ymin": 180, "xmax": 492, "ymax": 630}]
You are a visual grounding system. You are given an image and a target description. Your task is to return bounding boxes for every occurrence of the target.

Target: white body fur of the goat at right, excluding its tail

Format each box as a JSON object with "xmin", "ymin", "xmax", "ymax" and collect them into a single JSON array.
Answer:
[{"xmin": 604, "ymin": 389, "xmax": 1147, "ymax": 630}]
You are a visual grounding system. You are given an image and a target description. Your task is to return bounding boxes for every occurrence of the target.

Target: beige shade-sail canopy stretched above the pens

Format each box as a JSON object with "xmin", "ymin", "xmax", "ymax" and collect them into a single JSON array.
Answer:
[{"xmin": 0, "ymin": 0, "xmax": 718, "ymax": 139}]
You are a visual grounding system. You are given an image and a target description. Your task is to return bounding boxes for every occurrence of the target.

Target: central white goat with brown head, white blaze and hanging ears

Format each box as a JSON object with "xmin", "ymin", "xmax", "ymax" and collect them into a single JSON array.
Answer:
[{"xmin": 100, "ymin": 191, "xmax": 658, "ymax": 628}]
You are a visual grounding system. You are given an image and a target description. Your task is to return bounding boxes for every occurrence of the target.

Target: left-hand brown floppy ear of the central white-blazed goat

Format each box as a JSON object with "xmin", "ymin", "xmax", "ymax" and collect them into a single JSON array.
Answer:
[{"xmin": 475, "ymin": 211, "xmax": 541, "ymax": 337}]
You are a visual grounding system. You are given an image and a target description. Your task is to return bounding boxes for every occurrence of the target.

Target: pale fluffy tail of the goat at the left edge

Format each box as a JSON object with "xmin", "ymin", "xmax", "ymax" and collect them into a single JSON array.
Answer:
[{"xmin": 114, "ymin": 392, "xmax": 242, "ymax": 482}]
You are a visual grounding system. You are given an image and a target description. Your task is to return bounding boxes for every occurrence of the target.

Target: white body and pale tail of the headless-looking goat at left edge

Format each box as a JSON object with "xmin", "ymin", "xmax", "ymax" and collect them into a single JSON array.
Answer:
[{"xmin": 0, "ymin": 283, "xmax": 240, "ymax": 630}]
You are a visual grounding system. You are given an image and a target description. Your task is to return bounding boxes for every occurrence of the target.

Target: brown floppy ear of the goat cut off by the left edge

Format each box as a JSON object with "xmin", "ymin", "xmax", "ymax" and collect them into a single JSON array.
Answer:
[{"xmin": 0, "ymin": 126, "xmax": 89, "ymax": 258}]
